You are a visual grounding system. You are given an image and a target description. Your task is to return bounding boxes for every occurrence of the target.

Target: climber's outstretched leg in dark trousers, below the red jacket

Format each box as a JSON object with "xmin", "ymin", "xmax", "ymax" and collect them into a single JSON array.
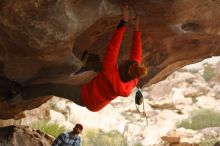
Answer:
[{"xmin": 21, "ymin": 83, "xmax": 83, "ymax": 106}]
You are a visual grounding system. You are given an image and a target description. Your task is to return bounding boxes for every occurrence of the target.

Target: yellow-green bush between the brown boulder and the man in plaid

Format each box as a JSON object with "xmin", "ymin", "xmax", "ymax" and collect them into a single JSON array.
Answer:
[{"xmin": 32, "ymin": 121, "xmax": 66, "ymax": 138}]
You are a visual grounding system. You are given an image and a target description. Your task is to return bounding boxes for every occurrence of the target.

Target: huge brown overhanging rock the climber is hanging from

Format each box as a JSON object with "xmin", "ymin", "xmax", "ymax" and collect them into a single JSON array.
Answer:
[{"xmin": 0, "ymin": 0, "xmax": 220, "ymax": 118}]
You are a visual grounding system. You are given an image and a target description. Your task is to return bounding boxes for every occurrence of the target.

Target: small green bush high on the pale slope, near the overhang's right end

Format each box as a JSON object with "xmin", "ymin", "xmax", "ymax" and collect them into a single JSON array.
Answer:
[{"xmin": 202, "ymin": 63, "xmax": 215, "ymax": 81}]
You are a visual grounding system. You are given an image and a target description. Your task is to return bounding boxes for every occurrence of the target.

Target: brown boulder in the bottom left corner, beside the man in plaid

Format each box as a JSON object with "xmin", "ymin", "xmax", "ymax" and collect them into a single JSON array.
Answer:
[{"xmin": 0, "ymin": 126, "xmax": 54, "ymax": 146}]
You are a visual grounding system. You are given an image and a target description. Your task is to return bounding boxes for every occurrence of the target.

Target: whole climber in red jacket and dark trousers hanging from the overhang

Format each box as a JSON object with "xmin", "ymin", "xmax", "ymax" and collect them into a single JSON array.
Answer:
[{"xmin": 2, "ymin": 6, "xmax": 147, "ymax": 111}]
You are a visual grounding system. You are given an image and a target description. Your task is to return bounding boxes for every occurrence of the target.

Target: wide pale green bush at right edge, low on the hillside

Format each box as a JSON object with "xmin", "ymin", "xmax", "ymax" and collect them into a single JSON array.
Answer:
[{"xmin": 176, "ymin": 109, "xmax": 220, "ymax": 130}]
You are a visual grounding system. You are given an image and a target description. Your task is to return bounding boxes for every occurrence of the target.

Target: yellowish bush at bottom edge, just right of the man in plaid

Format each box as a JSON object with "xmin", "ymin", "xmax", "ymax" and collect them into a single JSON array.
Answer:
[{"xmin": 83, "ymin": 129, "xmax": 128, "ymax": 146}]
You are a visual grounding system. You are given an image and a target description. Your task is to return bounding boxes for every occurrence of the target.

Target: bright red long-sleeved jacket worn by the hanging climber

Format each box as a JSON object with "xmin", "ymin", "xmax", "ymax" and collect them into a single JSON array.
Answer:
[{"xmin": 81, "ymin": 26, "xmax": 142, "ymax": 112}]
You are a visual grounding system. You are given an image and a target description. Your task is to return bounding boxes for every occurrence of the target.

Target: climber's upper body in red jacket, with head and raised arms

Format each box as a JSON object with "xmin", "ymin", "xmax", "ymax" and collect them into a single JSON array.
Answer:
[{"xmin": 81, "ymin": 7, "xmax": 147, "ymax": 111}]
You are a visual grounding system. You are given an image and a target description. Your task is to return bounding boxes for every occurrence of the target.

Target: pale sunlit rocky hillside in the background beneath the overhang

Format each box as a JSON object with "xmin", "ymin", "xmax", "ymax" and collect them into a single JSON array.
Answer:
[{"xmin": 0, "ymin": 57, "xmax": 220, "ymax": 146}]
